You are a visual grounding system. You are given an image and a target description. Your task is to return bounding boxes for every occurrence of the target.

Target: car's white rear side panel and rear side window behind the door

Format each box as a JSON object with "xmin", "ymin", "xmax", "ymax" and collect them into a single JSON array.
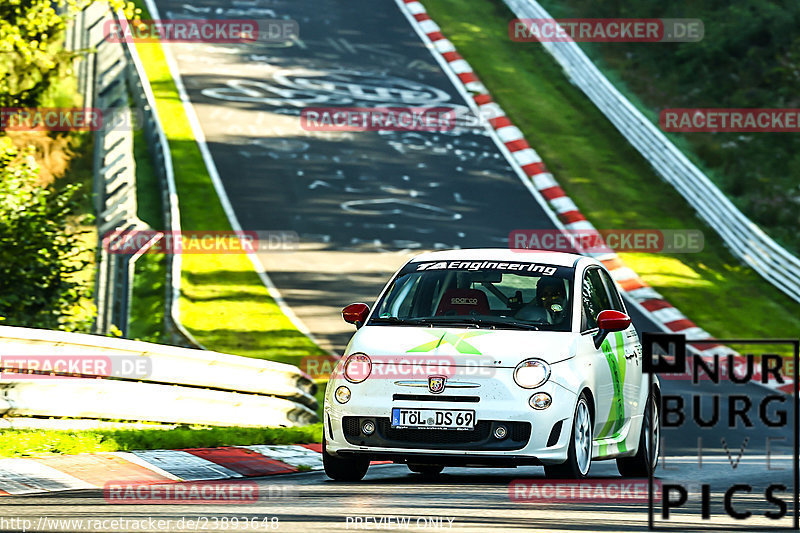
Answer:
[{"xmin": 599, "ymin": 269, "xmax": 644, "ymax": 422}]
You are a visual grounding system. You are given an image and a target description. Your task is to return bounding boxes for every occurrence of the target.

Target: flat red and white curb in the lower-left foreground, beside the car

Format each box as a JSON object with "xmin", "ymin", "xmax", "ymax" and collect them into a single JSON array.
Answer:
[{"xmin": 0, "ymin": 444, "xmax": 332, "ymax": 496}]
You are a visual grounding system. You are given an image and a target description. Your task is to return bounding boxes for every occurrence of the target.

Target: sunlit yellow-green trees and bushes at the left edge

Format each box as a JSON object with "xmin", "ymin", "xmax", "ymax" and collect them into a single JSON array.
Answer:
[{"xmin": 0, "ymin": 0, "xmax": 134, "ymax": 330}]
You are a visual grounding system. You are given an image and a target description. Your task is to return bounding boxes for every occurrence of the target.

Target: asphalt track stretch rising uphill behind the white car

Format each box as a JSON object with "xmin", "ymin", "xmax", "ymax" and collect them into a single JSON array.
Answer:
[{"xmin": 158, "ymin": 0, "xmax": 564, "ymax": 353}]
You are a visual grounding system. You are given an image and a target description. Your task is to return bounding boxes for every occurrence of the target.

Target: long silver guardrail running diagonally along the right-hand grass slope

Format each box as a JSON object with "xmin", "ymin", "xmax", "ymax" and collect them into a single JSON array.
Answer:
[{"xmin": 504, "ymin": 0, "xmax": 800, "ymax": 302}]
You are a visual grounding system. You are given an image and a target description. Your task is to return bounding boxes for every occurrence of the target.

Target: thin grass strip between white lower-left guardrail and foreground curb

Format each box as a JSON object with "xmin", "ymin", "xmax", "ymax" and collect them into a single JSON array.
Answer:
[{"xmin": 0, "ymin": 424, "xmax": 322, "ymax": 457}]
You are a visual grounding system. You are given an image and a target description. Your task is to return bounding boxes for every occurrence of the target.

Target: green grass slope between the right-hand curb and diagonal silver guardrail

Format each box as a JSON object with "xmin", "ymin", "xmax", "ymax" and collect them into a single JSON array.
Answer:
[{"xmin": 424, "ymin": 0, "xmax": 800, "ymax": 337}]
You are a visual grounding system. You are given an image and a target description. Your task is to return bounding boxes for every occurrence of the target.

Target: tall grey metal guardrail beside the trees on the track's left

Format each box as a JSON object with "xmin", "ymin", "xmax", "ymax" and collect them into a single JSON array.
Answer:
[{"xmin": 66, "ymin": 2, "xmax": 203, "ymax": 342}]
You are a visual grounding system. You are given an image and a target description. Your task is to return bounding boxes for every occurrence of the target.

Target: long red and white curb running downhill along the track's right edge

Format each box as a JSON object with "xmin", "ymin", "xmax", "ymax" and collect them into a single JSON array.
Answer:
[{"xmin": 397, "ymin": 0, "xmax": 793, "ymax": 392}]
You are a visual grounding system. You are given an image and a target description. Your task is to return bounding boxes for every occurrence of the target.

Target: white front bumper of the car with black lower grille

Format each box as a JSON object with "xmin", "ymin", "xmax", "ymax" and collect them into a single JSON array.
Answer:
[{"xmin": 324, "ymin": 369, "xmax": 577, "ymax": 466}]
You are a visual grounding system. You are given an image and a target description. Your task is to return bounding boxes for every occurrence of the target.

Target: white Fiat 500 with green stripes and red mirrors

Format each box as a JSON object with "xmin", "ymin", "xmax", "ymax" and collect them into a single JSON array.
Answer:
[{"xmin": 323, "ymin": 249, "xmax": 660, "ymax": 481}]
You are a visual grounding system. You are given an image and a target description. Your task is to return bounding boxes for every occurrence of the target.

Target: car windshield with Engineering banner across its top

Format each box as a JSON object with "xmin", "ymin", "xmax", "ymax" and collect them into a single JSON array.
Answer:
[{"xmin": 369, "ymin": 260, "xmax": 574, "ymax": 331}]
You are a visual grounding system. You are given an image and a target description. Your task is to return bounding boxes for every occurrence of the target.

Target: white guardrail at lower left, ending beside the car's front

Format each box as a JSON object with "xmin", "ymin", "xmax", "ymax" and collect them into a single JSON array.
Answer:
[{"xmin": 0, "ymin": 326, "xmax": 318, "ymax": 427}]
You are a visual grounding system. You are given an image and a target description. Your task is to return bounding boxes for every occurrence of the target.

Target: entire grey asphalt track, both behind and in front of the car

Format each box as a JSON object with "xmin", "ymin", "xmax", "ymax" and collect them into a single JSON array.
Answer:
[{"xmin": 6, "ymin": 0, "xmax": 793, "ymax": 531}]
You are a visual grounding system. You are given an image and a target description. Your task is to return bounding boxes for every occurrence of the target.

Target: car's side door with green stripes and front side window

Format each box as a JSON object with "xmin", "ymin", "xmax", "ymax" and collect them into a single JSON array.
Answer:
[{"xmin": 581, "ymin": 266, "xmax": 630, "ymax": 439}]
